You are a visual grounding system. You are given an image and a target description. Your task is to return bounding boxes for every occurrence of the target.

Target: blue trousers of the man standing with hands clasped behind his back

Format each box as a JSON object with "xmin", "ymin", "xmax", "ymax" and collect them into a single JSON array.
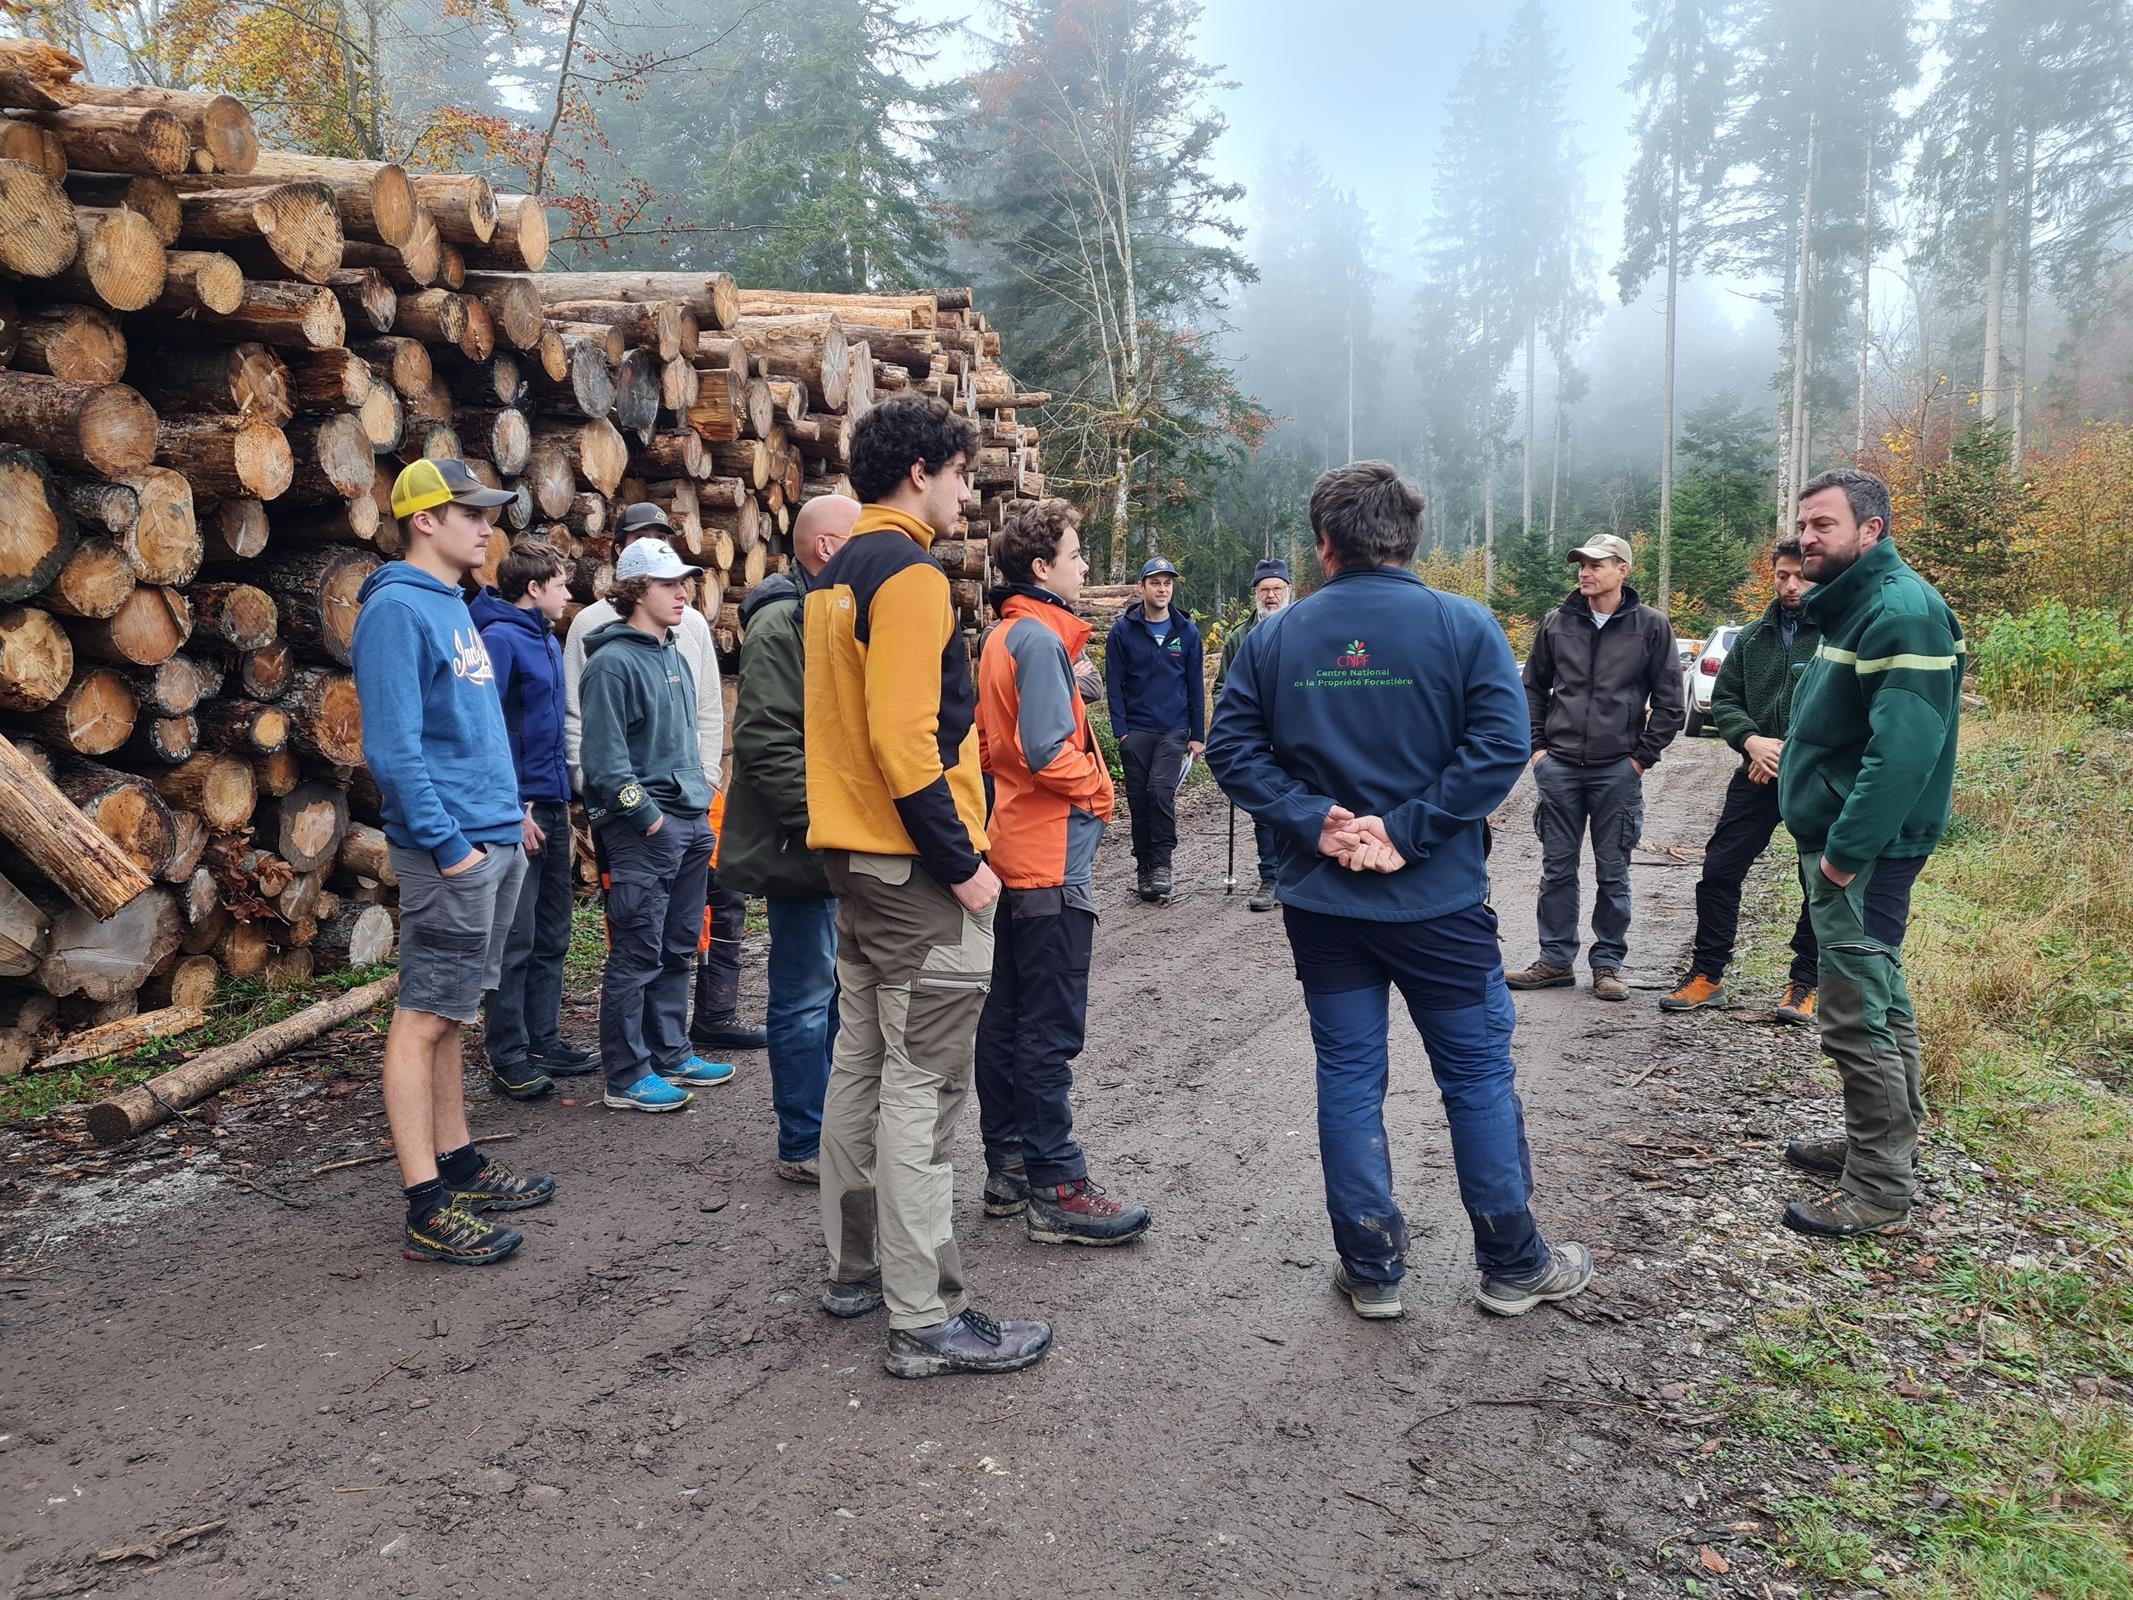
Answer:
[{"xmin": 1284, "ymin": 905, "xmax": 1546, "ymax": 1284}]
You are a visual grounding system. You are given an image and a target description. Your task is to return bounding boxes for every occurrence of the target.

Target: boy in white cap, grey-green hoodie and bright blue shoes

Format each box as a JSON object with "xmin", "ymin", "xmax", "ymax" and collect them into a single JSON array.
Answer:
[{"xmin": 578, "ymin": 540, "xmax": 734, "ymax": 1111}]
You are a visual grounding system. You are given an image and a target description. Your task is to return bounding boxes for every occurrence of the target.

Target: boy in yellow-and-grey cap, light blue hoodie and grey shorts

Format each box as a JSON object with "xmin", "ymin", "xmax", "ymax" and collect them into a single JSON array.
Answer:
[{"xmin": 354, "ymin": 461, "xmax": 555, "ymax": 1265}]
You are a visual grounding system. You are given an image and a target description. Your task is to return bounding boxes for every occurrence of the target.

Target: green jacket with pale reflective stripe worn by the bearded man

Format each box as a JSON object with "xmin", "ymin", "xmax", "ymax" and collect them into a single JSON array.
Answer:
[{"xmin": 1777, "ymin": 540, "xmax": 1967, "ymax": 873}]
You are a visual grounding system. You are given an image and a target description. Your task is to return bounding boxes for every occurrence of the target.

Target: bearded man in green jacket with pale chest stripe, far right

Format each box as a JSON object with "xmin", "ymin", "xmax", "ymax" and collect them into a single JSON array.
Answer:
[{"xmin": 1777, "ymin": 469, "xmax": 1964, "ymax": 1237}]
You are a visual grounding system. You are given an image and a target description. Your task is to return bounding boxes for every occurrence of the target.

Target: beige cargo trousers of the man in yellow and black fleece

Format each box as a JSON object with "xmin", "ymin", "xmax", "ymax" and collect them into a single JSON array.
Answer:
[{"xmin": 821, "ymin": 851, "xmax": 994, "ymax": 1329}]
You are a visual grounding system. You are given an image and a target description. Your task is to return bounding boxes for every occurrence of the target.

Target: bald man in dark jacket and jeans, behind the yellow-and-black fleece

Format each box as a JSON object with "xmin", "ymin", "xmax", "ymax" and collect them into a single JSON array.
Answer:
[{"xmin": 719, "ymin": 495, "xmax": 860, "ymax": 1184}]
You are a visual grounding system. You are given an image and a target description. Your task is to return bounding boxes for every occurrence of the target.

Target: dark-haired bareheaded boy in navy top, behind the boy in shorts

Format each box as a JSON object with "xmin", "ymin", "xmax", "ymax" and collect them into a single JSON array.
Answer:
[{"xmin": 471, "ymin": 540, "xmax": 597, "ymax": 1101}]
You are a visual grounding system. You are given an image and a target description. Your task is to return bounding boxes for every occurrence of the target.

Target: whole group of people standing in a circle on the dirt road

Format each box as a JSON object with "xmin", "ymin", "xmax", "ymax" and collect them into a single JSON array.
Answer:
[{"xmin": 354, "ymin": 409, "xmax": 1962, "ymax": 1378}]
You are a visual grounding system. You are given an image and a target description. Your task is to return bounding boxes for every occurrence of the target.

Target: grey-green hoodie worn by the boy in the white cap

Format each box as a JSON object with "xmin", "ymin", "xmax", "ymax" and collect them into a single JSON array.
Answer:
[{"xmin": 578, "ymin": 623, "xmax": 710, "ymax": 834}]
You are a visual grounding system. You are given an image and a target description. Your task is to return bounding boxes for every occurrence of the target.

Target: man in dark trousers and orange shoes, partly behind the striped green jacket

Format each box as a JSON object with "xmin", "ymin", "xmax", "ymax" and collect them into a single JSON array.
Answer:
[{"xmin": 1659, "ymin": 533, "xmax": 1822, "ymax": 1022}]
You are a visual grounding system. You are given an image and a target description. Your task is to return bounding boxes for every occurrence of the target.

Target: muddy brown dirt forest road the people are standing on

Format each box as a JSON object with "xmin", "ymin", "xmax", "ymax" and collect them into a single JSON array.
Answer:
[{"xmin": 0, "ymin": 740, "xmax": 1732, "ymax": 1600}]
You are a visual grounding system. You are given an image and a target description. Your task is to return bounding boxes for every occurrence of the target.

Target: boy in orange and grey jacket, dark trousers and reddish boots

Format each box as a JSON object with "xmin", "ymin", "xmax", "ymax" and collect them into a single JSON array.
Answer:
[{"xmin": 977, "ymin": 499, "xmax": 1148, "ymax": 1244}]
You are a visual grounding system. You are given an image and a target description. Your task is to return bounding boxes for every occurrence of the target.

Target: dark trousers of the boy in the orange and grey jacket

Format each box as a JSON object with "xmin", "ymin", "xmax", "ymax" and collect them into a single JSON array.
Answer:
[{"xmin": 977, "ymin": 890, "xmax": 1096, "ymax": 1184}]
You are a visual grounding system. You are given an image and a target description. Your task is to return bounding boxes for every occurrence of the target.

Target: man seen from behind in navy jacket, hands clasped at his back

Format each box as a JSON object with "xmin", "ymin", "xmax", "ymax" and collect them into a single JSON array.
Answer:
[{"xmin": 1207, "ymin": 461, "xmax": 1593, "ymax": 1316}]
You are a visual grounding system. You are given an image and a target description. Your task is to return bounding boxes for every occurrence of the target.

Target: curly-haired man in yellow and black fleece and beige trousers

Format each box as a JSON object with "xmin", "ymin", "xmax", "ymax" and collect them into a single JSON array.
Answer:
[{"xmin": 806, "ymin": 395, "xmax": 1052, "ymax": 1378}]
